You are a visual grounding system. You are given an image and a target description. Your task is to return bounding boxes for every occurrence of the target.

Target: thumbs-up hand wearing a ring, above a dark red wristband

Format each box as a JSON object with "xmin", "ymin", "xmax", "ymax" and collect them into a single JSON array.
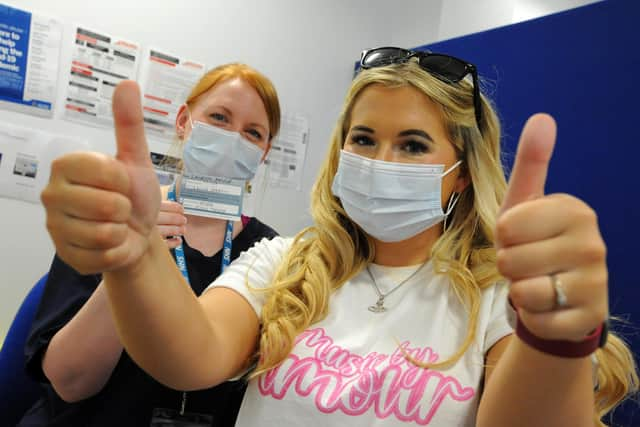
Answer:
[{"xmin": 496, "ymin": 114, "xmax": 608, "ymax": 341}]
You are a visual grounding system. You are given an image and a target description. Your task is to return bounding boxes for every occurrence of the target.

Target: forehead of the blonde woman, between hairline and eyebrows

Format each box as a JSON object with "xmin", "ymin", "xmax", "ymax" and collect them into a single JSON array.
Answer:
[{"xmin": 351, "ymin": 84, "xmax": 444, "ymax": 130}]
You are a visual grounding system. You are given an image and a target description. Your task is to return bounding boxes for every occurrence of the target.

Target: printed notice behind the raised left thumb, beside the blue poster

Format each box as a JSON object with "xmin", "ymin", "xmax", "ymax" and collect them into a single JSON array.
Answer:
[{"xmin": 64, "ymin": 27, "xmax": 140, "ymax": 127}]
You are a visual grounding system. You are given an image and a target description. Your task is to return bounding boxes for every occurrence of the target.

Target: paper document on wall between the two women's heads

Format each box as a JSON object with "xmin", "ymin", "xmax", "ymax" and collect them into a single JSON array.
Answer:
[{"xmin": 265, "ymin": 114, "xmax": 309, "ymax": 191}]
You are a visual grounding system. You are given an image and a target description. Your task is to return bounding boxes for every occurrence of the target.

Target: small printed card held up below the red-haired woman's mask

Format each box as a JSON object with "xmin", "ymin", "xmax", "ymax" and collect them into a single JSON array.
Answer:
[{"xmin": 180, "ymin": 174, "xmax": 245, "ymax": 221}]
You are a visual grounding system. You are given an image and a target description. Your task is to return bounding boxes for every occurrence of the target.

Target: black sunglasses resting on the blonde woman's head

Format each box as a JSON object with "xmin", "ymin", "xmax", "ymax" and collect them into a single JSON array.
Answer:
[{"xmin": 360, "ymin": 47, "xmax": 482, "ymax": 132}]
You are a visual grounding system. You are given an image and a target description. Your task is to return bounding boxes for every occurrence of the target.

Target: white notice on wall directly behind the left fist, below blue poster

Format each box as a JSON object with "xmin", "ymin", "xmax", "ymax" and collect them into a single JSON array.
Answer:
[{"xmin": 0, "ymin": 124, "xmax": 89, "ymax": 203}]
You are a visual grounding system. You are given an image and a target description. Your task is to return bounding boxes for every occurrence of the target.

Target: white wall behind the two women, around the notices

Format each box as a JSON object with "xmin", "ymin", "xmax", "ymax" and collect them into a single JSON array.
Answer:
[{"xmin": 0, "ymin": 0, "xmax": 592, "ymax": 338}]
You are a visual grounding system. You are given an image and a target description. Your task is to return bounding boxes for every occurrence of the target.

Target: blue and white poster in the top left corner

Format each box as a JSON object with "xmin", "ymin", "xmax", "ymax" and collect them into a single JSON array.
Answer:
[{"xmin": 0, "ymin": 4, "xmax": 62, "ymax": 117}]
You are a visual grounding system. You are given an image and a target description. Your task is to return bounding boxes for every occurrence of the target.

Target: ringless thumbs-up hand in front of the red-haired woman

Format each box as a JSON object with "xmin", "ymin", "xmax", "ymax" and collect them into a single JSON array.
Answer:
[{"xmin": 41, "ymin": 81, "xmax": 160, "ymax": 274}]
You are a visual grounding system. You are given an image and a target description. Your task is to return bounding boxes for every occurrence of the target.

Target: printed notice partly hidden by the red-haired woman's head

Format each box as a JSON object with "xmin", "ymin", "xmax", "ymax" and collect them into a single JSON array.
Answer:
[{"xmin": 140, "ymin": 49, "xmax": 205, "ymax": 141}]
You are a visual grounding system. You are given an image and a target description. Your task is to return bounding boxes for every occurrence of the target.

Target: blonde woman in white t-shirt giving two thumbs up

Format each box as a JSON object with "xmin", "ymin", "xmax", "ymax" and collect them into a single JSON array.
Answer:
[{"xmin": 43, "ymin": 48, "xmax": 637, "ymax": 427}]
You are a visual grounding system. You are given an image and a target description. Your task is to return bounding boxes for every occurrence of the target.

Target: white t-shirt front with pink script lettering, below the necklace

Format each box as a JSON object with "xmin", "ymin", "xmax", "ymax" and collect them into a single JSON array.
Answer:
[{"xmin": 244, "ymin": 281, "xmax": 484, "ymax": 425}]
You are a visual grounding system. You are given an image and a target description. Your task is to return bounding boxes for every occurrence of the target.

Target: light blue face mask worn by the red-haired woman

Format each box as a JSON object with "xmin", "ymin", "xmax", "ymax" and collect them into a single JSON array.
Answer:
[{"xmin": 182, "ymin": 121, "xmax": 264, "ymax": 180}]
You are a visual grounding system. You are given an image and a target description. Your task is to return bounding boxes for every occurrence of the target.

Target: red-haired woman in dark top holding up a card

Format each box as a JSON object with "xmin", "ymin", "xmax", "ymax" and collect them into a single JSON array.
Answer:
[{"xmin": 21, "ymin": 64, "xmax": 280, "ymax": 427}]
